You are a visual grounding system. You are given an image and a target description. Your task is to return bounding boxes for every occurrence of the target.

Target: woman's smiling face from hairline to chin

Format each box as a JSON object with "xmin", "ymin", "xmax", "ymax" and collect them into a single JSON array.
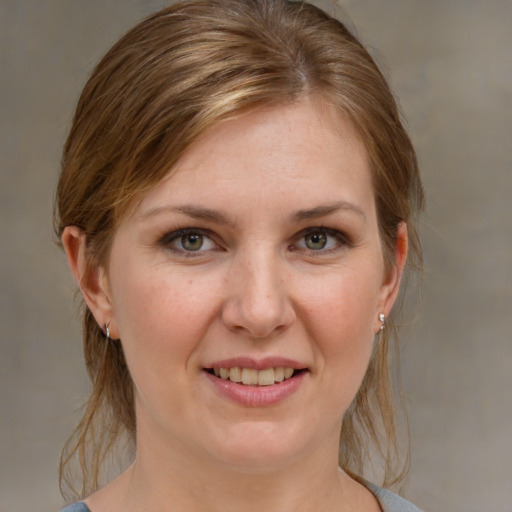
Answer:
[{"xmin": 96, "ymin": 104, "xmax": 397, "ymax": 470}]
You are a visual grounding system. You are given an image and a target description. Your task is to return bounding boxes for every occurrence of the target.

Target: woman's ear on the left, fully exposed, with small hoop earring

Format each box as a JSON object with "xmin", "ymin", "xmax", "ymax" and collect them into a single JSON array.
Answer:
[{"xmin": 61, "ymin": 226, "xmax": 119, "ymax": 338}]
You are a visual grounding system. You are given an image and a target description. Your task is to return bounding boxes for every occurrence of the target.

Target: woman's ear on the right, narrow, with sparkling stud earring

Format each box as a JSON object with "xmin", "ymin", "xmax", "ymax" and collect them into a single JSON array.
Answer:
[{"xmin": 374, "ymin": 222, "xmax": 408, "ymax": 333}]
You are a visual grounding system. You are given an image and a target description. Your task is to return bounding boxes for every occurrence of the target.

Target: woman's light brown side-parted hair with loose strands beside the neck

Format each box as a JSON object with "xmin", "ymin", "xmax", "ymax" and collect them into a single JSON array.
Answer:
[{"xmin": 54, "ymin": 0, "xmax": 423, "ymax": 497}]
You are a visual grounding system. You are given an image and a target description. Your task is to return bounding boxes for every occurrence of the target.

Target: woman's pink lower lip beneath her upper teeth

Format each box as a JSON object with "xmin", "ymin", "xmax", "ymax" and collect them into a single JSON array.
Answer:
[{"xmin": 204, "ymin": 371, "xmax": 308, "ymax": 407}]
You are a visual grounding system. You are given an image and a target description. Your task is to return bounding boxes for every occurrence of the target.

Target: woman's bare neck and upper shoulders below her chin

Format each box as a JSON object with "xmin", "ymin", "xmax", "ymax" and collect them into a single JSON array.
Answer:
[{"xmin": 87, "ymin": 412, "xmax": 379, "ymax": 512}]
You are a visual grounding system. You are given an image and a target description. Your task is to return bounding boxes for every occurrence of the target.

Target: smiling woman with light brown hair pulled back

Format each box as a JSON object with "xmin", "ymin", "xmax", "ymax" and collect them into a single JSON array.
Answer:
[{"xmin": 56, "ymin": 0, "xmax": 423, "ymax": 512}]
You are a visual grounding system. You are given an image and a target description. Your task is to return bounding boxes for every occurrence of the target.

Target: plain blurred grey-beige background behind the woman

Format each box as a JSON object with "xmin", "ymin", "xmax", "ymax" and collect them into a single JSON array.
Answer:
[{"xmin": 0, "ymin": 0, "xmax": 512, "ymax": 512}]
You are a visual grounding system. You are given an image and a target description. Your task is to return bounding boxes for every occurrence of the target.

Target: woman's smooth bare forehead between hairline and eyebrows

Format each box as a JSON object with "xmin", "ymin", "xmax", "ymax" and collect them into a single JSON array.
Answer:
[{"xmin": 133, "ymin": 102, "xmax": 373, "ymax": 220}]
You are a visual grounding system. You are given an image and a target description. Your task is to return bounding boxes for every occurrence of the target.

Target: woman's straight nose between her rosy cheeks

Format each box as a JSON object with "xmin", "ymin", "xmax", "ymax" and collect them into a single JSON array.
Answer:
[{"xmin": 222, "ymin": 250, "xmax": 296, "ymax": 339}]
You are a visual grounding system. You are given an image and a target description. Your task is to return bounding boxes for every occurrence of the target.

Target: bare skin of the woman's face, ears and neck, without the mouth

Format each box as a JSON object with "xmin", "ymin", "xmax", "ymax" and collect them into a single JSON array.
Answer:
[{"xmin": 63, "ymin": 102, "xmax": 407, "ymax": 512}]
